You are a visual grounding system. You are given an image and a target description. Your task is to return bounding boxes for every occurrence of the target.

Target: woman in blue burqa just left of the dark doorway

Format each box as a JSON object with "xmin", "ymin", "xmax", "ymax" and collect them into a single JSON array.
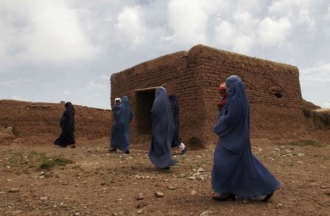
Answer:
[{"xmin": 109, "ymin": 96, "xmax": 133, "ymax": 154}]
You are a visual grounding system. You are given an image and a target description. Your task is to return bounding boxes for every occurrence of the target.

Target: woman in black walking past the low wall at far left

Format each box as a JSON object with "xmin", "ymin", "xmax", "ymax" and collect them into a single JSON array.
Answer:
[{"xmin": 54, "ymin": 102, "xmax": 76, "ymax": 148}]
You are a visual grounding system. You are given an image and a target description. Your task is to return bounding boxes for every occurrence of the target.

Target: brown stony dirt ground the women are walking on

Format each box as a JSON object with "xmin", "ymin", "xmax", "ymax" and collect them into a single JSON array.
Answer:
[{"xmin": 0, "ymin": 138, "xmax": 330, "ymax": 216}]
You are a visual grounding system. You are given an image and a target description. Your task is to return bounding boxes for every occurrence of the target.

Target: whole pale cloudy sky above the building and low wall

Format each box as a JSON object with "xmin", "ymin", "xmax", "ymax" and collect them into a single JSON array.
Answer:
[{"xmin": 0, "ymin": 0, "xmax": 330, "ymax": 109}]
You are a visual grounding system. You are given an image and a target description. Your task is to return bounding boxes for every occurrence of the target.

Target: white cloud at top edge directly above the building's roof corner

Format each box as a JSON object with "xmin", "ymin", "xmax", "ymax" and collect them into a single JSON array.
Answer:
[{"xmin": 161, "ymin": 0, "xmax": 230, "ymax": 45}]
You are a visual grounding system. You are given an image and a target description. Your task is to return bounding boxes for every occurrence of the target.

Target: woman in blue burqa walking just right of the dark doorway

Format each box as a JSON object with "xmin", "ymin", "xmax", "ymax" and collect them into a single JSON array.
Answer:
[{"xmin": 148, "ymin": 87, "xmax": 177, "ymax": 170}]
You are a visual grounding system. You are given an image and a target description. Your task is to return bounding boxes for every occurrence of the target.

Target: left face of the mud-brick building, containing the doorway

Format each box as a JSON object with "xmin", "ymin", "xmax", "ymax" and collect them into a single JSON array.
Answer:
[{"xmin": 110, "ymin": 51, "xmax": 208, "ymax": 145}]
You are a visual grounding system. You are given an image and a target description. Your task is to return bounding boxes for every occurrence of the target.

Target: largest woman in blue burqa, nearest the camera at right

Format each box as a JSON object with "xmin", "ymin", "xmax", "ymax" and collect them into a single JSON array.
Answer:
[{"xmin": 212, "ymin": 75, "xmax": 280, "ymax": 201}]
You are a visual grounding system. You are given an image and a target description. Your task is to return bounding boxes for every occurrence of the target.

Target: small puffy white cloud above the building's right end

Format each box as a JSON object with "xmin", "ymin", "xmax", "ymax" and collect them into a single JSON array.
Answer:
[{"xmin": 258, "ymin": 17, "xmax": 292, "ymax": 46}]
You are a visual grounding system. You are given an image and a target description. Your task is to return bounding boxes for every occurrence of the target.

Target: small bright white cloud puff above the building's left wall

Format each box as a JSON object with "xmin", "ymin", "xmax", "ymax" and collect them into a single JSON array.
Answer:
[{"xmin": 115, "ymin": 7, "xmax": 147, "ymax": 44}]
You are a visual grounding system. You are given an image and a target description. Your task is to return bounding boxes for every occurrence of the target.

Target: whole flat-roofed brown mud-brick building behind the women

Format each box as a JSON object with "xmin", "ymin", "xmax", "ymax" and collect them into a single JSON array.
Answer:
[{"xmin": 110, "ymin": 45, "xmax": 324, "ymax": 148}]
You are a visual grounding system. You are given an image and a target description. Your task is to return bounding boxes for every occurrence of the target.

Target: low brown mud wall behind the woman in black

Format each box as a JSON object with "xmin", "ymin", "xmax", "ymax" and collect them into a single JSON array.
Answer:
[{"xmin": 0, "ymin": 100, "xmax": 111, "ymax": 144}]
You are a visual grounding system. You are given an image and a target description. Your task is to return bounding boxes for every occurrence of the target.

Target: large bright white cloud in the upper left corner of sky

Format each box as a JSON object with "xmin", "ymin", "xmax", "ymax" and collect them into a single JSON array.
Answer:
[{"xmin": 0, "ymin": 0, "xmax": 97, "ymax": 63}]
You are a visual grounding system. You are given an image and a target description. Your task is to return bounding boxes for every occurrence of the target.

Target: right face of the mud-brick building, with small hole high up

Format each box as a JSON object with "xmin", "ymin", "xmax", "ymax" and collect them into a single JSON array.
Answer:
[{"xmin": 189, "ymin": 45, "xmax": 307, "ymax": 143}]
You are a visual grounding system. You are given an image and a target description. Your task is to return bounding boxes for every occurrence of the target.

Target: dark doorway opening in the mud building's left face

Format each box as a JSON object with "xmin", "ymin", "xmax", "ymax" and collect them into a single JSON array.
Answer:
[{"xmin": 135, "ymin": 87, "xmax": 157, "ymax": 140}]
